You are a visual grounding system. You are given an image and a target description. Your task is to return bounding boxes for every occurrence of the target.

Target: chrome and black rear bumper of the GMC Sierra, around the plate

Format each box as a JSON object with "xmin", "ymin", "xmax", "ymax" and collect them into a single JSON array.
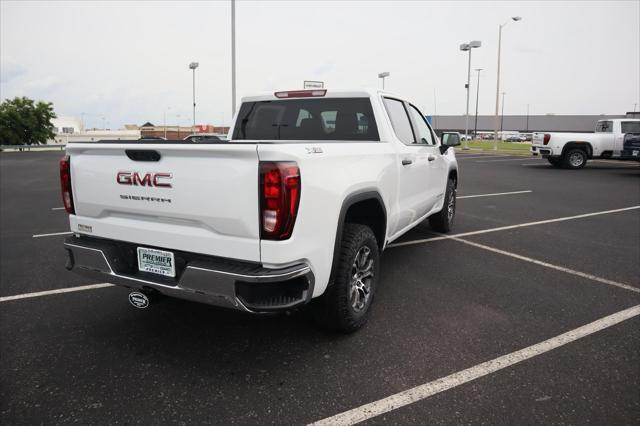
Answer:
[{"xmin": 64, "ymin": 236, "xmax": 314, "ymax": 313}]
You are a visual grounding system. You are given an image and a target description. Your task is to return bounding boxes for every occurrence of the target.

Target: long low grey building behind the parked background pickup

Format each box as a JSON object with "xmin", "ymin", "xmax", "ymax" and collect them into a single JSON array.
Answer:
[{"xmin": 430, "ymin": 112, "xmax": 640, "ymax": 133}]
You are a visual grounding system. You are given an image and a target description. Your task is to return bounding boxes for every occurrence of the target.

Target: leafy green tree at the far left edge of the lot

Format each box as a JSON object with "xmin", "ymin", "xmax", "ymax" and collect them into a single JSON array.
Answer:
[{"xmin": 0, "ymin": 96, "xmax": 56, "ymax": 145}]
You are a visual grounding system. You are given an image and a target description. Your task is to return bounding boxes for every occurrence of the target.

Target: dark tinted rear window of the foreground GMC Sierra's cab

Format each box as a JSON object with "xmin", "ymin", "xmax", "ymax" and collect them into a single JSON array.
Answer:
[{"xmin": 233, "ymin": 98, "xmax": 380, "ymax": 141}]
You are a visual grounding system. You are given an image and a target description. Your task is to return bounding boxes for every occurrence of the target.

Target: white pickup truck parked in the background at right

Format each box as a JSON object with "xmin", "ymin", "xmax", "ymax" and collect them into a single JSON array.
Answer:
[{"xmin": 531, "ymin": 118, "xmax": 640, "ymax": 169}]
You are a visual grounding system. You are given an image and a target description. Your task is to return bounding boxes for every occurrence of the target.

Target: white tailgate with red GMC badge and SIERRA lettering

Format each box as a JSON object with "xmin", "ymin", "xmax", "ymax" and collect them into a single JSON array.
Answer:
[{"xmin": 67, "ymin": 142, "xmax": 260, "ymax": 261}]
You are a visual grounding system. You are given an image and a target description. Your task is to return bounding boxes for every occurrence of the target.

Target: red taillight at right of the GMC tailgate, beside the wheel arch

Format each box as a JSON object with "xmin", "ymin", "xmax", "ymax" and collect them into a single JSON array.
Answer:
[{"xmin": 260, "ymin": 162, "xmax": 300, "ymax": 240}]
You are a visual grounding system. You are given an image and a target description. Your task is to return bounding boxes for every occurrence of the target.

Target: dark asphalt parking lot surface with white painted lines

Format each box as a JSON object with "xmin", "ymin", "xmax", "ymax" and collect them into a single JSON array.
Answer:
[{"xmin": 0, "ymin": 152, "xmax": 640, "ymax": 424}]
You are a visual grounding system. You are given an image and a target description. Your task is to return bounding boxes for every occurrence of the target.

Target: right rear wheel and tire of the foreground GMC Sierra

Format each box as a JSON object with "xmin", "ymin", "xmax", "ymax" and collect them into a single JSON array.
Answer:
[{"xmin": 311, "ymin": 223, "xmax": 380, "ymax": 333}]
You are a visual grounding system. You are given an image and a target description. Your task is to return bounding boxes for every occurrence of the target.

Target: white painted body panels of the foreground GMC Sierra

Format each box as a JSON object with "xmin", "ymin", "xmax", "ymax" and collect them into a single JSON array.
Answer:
[{"xmin": 67, "ymin": 90, "xmax": 457, "ymax": 297}]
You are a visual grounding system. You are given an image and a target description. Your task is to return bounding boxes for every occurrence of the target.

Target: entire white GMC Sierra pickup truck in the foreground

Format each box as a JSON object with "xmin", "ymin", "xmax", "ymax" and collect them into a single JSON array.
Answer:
[{"xmin": 60, "ymin": 90, "xmax": 460, "ymax": 332}]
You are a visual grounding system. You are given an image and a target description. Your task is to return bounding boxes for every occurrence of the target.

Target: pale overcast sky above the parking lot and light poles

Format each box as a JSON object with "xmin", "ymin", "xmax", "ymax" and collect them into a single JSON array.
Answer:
[{"xmin": 0, "ymin": 0, "xmax": 640, "ymax": 128}]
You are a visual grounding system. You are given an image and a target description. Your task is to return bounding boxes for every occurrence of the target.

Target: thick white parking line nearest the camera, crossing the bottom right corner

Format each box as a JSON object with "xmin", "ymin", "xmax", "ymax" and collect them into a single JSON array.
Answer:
[{"xmin": 312, "ymin": 305, "xmax": 640, "ymax": 425}]
